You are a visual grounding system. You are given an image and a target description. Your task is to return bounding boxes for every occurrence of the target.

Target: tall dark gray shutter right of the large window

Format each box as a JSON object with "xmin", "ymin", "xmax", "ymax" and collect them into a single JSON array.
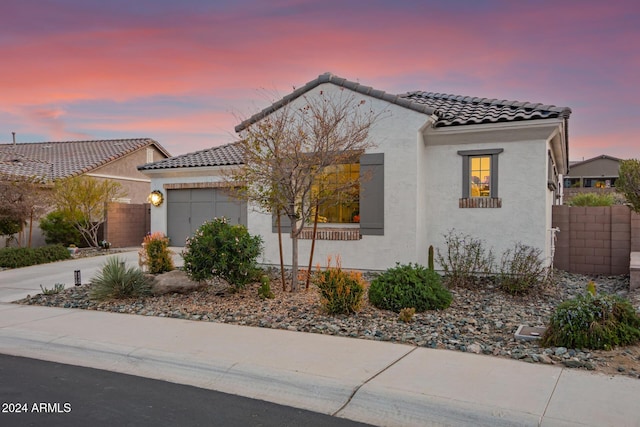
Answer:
[{"xmin": 360, "ymin": 153, "xmax": 384, "ymax": 236}]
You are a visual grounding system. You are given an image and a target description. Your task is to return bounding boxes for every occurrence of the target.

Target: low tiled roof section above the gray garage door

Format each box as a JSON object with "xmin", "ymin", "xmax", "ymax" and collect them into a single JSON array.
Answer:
[{"xmin": 138, "ymin": 142, "xmax": 243, "ymax": 171}]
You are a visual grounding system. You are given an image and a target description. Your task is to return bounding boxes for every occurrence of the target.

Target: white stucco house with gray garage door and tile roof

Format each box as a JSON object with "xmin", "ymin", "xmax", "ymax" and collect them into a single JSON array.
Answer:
[{"xmin": 139, "ymin": 73, "xmax": 571, "ymax": 270}]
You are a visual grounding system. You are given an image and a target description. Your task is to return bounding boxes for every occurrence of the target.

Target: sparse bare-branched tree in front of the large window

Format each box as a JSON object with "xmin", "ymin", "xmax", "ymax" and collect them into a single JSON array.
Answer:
[{"xmin": 231, "ymin": 89, "xmax": 379, "ymax": 291}]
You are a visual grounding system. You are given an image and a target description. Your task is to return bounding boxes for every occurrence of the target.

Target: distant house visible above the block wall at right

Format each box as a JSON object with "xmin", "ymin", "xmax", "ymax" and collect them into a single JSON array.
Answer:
[{"xmin": 563, "ymin": 154, "xmax": 622, "ymax": 188}]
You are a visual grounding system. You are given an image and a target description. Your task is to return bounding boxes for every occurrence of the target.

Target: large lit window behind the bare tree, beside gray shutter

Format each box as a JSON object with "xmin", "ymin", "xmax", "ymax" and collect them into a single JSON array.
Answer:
[{"xmin": 311, "ymin": 163, "xmax": 360, "ymax": 224}]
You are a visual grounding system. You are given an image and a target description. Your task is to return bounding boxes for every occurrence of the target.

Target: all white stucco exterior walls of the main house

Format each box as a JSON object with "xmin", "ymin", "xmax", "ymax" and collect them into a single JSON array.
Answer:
[{"xmin": 146, "ymin": 84, "xmax": 561, "ymax": 270}]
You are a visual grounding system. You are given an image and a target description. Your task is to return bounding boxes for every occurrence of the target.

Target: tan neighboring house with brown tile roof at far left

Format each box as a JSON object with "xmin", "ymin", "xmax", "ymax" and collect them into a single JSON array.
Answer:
[{"xmin": 0, "ymin": 138, "xmax": 170, "ymax": 246}]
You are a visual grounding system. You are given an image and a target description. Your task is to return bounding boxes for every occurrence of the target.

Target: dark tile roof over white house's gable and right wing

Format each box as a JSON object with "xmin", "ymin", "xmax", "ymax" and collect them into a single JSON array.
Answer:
[{"xmin": 235, "ymin": 73, "xmax": 571, "ymax": 132}]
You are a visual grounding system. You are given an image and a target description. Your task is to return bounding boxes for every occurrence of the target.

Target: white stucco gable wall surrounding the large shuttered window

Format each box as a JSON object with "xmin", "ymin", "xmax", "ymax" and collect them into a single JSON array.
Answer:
[{"xmin": 248, "ymin": 84, "xmax": 429, "ymax": 270}]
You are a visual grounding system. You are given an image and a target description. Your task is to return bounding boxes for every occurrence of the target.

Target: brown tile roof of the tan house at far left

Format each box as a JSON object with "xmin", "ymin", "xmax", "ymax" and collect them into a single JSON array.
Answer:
[{"xmin": 0, "ymin": 138, "xmax": 170, "ymax": 181}]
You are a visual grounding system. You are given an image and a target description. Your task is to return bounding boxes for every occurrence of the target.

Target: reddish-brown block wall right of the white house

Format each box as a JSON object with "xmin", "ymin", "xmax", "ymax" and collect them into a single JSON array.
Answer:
[{"xmin": 552, "ymin": 206, "xmax": 640, "ymax": 275}]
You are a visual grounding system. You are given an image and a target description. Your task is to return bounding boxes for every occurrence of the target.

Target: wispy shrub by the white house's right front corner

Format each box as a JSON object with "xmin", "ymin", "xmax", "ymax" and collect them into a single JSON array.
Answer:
[{"xmin": 497, "ymin": 242, "xmax": 550, "ymax": 295}]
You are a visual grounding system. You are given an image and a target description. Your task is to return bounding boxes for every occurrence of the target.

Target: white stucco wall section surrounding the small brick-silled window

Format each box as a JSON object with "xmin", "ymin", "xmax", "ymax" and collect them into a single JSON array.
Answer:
[{"xmin": 424, "ymin": 122, "xmax": 553, "ymax": 268}]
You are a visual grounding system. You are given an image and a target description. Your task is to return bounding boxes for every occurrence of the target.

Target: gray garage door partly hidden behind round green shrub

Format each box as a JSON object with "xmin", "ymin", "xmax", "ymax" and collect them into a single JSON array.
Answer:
[{"xmin": 167, "ymin": 188, "xmax": 247, "ymax": 246}]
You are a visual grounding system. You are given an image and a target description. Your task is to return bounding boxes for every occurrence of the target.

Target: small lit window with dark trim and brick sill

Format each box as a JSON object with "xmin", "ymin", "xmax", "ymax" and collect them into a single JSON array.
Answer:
[{"xmin": 458, "ymin": 148, "xmax": 504, "ymax": 207}]
